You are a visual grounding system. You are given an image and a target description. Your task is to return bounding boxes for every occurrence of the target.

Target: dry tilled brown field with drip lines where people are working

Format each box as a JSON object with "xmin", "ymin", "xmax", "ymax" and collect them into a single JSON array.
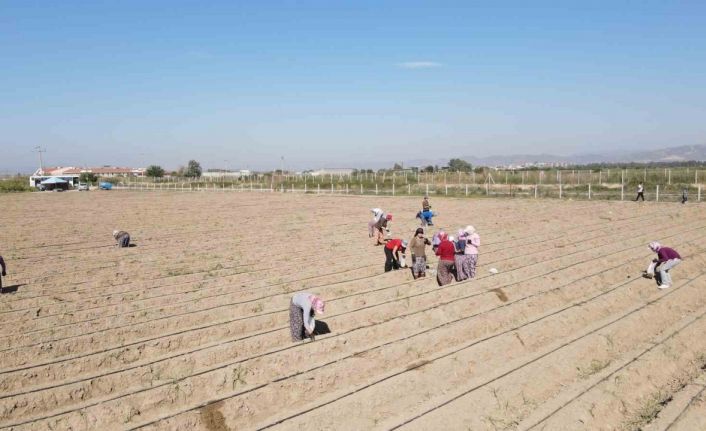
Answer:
[{"xmin": 0, "ymin": 191, "xmax": 706, "ymax": 431}]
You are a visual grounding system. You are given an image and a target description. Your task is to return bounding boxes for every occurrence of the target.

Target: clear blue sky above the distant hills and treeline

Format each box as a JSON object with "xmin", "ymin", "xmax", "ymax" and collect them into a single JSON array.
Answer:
[{"xmin": 0, "ymin": 0, "xmax": 706, "ymax": 172}]
